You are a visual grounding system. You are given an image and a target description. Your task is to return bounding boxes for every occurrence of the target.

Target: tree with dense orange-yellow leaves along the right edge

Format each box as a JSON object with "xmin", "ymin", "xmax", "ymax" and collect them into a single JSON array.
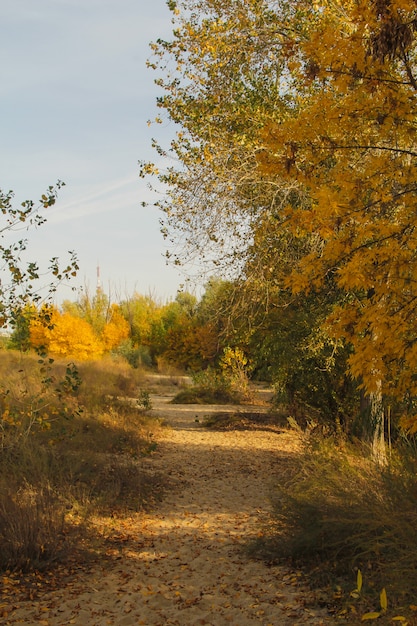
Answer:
[{"xmin": 259, "ymin": 0, "xmax": 417, "ymax": 448}]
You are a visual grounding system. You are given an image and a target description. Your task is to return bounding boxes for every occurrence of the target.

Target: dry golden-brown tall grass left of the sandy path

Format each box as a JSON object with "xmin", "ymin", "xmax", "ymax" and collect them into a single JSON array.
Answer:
[{"xmin": 0, "ymin": 350, "xmax": 156, "ymax": 570}]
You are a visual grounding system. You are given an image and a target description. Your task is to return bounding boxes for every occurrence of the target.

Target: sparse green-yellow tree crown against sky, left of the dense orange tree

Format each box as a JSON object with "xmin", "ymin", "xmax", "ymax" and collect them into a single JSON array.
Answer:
[{"xmin": 141, "ymin": 0, "xmax": 289, "ymax": 278}]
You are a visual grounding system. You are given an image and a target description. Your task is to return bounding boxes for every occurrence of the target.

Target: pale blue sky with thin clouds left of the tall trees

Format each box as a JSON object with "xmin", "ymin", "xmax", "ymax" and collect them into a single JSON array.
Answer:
[{"xmin": 0, "ymin": 0, "xmax": 187, "ymax": 301}]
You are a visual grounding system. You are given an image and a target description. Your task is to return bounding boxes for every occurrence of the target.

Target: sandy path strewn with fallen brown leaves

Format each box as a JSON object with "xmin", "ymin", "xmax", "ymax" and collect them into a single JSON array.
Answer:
[{"xmin": 1, "ymin": 397, "xmax": 332, "ymax": 626}]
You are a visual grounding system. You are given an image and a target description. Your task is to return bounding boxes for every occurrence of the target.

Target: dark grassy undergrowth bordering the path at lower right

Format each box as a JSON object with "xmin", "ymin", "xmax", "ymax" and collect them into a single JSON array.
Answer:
[{"xmin": 251, "ymin": 435, "xmax": 417, "ymax": 624}]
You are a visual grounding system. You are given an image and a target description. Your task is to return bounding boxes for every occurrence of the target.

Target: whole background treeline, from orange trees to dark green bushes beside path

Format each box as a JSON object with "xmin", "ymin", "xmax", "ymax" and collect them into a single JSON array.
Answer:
[{"xmin": 7, "ymin": 278, "xmax": 360, "ymax": 432}]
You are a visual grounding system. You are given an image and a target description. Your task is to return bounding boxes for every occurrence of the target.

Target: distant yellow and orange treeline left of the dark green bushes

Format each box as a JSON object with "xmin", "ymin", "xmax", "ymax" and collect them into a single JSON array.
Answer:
[{"xmin": 7, "ymin": 281, "xmax": 221, "ymax": 371}]
